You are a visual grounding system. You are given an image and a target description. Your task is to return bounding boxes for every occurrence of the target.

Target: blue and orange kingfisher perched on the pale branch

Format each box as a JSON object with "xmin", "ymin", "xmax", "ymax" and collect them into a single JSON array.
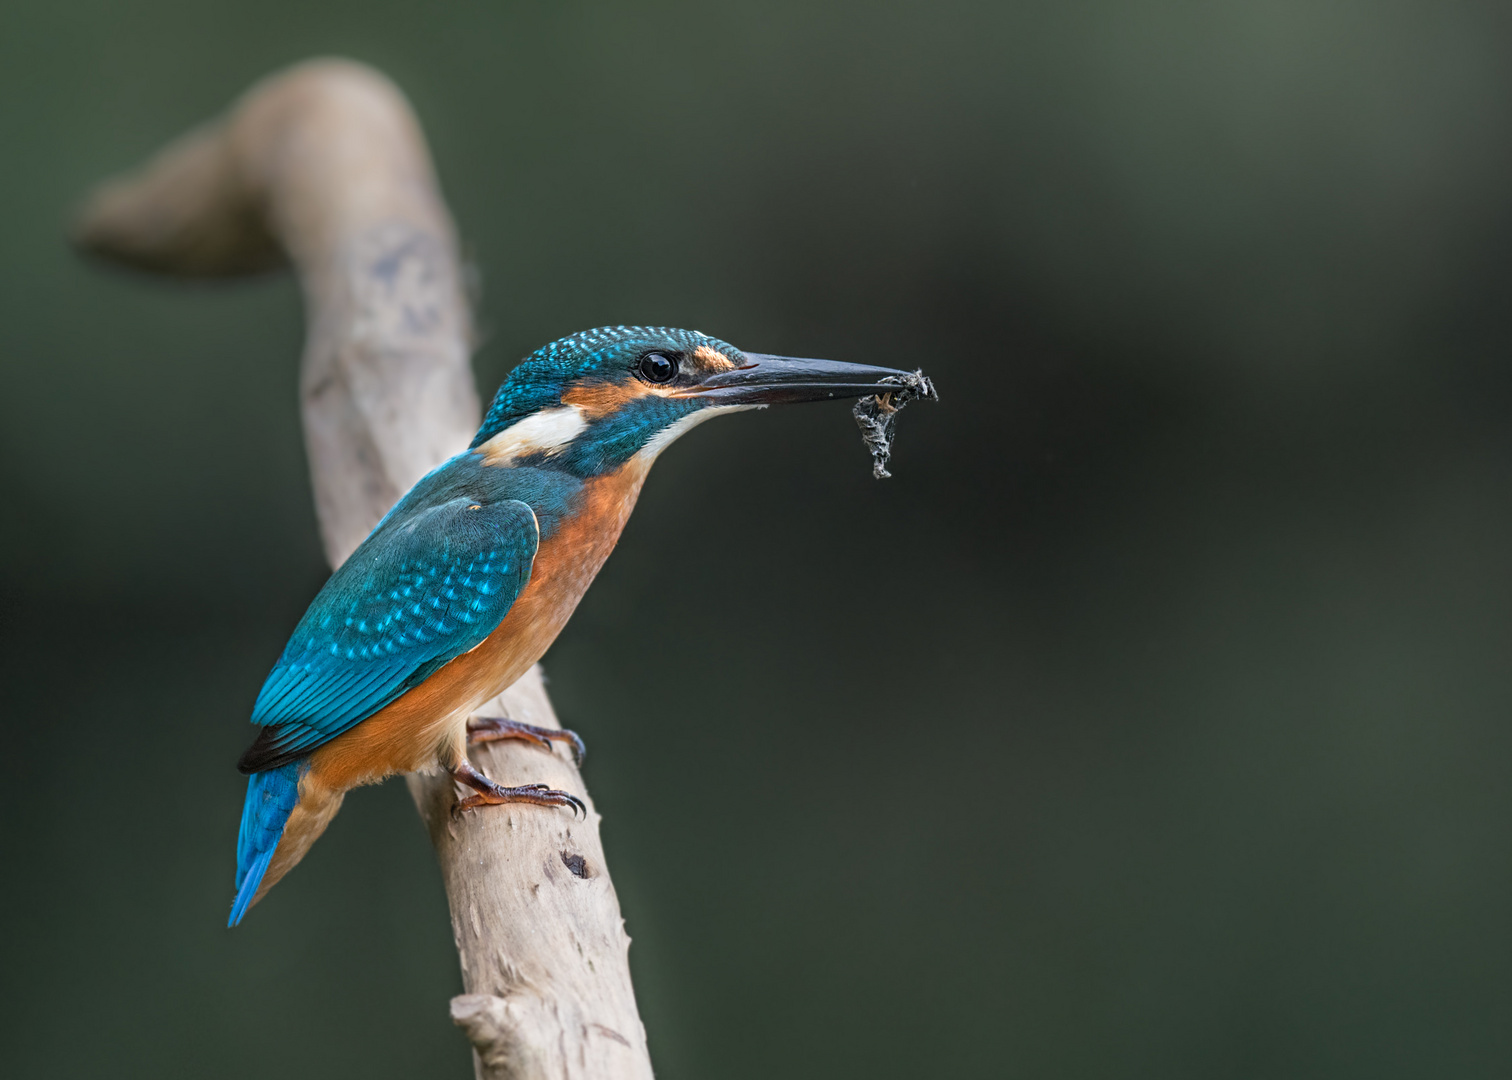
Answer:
[{"xmin": 228, "ymin": 327, "xmax": 909, "ymax": 927}]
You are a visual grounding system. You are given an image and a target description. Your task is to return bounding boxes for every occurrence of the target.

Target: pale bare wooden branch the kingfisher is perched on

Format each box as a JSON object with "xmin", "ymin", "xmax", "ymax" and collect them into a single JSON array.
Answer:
[{"xmin": 74, "ymin": 61, "xmax": 652, "ymax": 1080}]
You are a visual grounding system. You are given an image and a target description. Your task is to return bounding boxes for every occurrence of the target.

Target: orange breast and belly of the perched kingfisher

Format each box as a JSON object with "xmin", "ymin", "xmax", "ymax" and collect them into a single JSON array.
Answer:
[{"xmin": 301, "ymin": 458, "xmax": 650, "ymax": 794}]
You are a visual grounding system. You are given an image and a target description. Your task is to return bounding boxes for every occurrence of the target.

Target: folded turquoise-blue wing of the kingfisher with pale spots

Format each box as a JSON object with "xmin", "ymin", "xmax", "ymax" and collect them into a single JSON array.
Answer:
[{"xmin": 240, "ymin": 498, "xmax": 540, "ymax": 773}]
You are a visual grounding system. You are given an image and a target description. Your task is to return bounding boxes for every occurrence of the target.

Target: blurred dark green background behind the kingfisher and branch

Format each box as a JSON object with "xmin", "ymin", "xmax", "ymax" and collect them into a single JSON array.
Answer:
[{"xmin": 0, "ymin": 0, "xmax": 1512, "ymax": 1080}]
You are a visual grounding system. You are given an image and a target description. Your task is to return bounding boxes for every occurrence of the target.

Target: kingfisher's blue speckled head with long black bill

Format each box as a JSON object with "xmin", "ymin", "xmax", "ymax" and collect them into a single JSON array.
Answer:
[{"xmin": 472, "ymin": 327, "xmax": 906, "ymax": 478}]
